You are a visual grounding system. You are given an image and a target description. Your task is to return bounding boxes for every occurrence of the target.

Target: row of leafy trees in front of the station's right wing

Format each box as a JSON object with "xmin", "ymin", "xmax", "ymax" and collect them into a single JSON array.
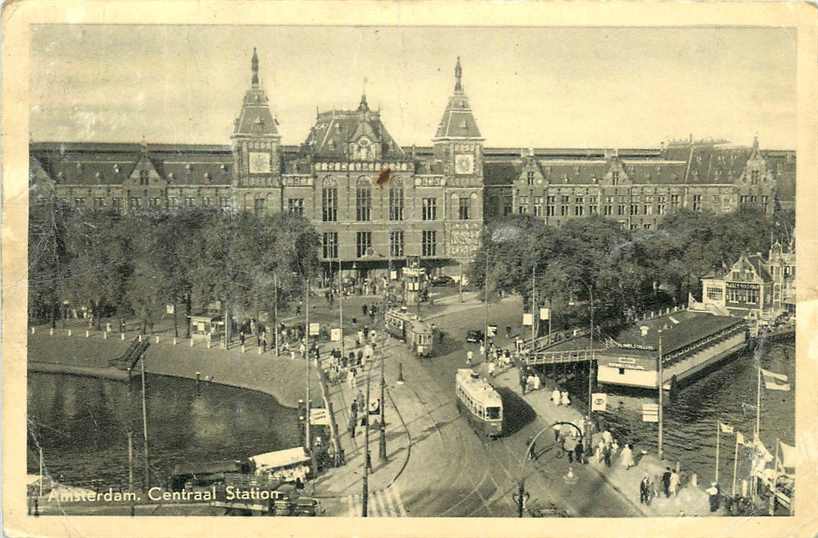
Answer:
[{"xmin": 470, "ymin": 209, "xmax": 795, "ymax": 325}]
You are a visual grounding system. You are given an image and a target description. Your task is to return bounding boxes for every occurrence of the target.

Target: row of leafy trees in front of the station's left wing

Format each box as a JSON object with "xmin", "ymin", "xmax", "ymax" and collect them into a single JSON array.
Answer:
[{"xmin": 29, "ymin": 200, "xmax": 320, "ymax": 335}]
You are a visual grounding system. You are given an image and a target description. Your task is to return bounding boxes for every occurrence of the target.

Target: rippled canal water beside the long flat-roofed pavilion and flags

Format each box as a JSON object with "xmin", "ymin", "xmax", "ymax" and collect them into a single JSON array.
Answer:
[{"xmin": 569, "ymin": 343, "xmax": 796, "ymax": 487}]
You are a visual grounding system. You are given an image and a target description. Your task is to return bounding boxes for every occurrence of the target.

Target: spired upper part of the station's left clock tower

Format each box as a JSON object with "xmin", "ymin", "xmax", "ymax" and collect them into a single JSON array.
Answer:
[{"xmin": 230, "ymin": 48, "xmax": 281, "ymax": 186}]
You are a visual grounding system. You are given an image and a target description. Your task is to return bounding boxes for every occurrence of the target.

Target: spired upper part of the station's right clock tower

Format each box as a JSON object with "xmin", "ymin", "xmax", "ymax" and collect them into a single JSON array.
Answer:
[{"xmin": 432, "ymin": 57, "xmax": 484, "ymax": 180}]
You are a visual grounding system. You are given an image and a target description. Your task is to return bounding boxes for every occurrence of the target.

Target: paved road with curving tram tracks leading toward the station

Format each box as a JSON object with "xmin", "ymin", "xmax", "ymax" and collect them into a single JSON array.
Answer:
[{"xmin": 356, "ymin": 301, "xmax": 638, "ymax": 517}]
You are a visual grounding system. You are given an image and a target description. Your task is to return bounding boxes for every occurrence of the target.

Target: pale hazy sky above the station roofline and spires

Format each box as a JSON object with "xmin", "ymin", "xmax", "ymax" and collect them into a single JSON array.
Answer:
[{"xmin": 30, "ymin": 25, "xmax": 796, "ymax": 149}]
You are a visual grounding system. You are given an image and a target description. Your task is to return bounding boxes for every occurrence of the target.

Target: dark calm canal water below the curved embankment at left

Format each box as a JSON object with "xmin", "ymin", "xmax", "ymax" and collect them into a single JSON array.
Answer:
[{"xmin": 28, "ymin": 373, "xmax": 301, "ymax": 488}]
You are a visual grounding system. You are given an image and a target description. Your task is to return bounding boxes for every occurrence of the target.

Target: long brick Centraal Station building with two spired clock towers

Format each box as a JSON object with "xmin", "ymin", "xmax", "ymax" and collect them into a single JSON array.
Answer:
[{"xmin": 30, "ymin": 51, "xmax": 795, "ymax": 276}]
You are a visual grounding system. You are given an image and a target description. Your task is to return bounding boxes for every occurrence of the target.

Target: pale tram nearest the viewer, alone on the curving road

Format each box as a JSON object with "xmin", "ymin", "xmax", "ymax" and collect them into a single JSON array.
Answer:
[{"xmin": 455, "ymin": 368, "xmax": 503, "ymax": 437}]
